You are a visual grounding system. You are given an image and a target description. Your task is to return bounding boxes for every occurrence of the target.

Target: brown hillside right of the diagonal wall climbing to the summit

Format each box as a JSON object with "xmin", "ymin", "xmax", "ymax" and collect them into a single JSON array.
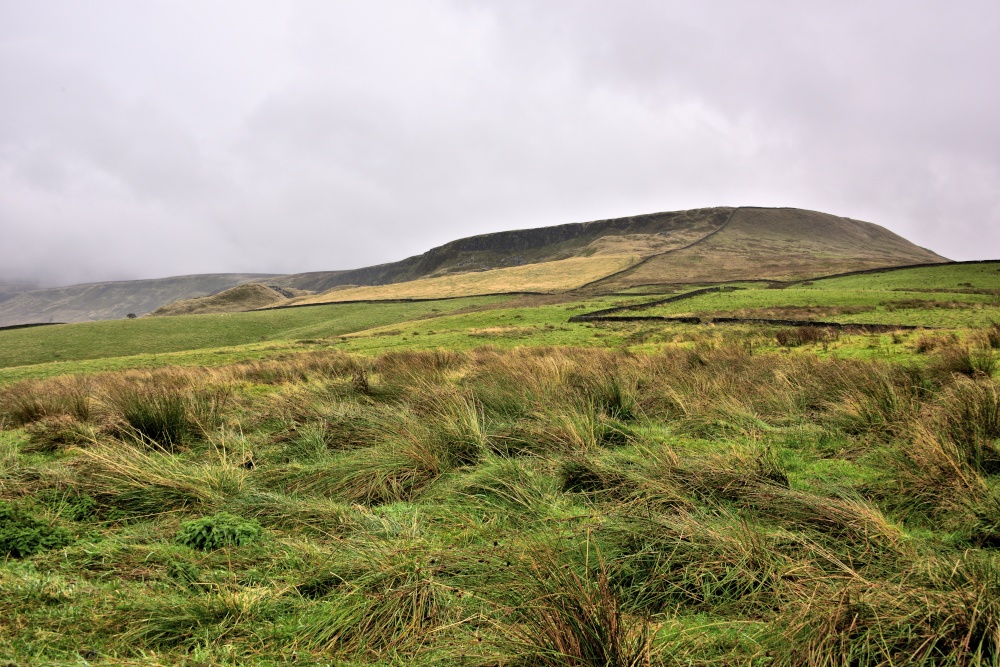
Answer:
[{"xmin": 595, "ymin": 207, "xmax": 948, "ymax": 289}]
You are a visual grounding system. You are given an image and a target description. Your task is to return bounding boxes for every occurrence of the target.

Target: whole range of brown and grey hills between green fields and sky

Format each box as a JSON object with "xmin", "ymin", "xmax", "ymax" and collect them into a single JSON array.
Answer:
[{"xmin": 0, "ymin": 207, "xmax": 948, "ymax": 326}]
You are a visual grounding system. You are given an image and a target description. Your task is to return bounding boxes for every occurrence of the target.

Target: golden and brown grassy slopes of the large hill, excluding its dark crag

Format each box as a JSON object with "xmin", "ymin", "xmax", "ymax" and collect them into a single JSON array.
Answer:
[{"xmin": 299, "ymin": 208, "xmax": 947, "ymax": 303}]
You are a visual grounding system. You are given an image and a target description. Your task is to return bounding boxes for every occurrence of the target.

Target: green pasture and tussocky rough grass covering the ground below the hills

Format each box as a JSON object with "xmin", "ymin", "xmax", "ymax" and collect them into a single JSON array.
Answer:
[{"xmin": 0, "ymin": 265, "xmax": 1000, "ymax": 667}]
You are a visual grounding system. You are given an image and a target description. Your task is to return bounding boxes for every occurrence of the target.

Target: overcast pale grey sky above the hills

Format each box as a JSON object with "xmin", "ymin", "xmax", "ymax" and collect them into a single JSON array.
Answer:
[{"xmin": 0, "ymin": 0, "xmax": 1000, "ymax": 285}]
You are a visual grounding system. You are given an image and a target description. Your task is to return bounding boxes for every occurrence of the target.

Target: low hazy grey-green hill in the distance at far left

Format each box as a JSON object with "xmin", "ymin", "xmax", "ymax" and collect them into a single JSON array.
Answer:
[{"xmin": 0, "ymin": 273, "xmax": 271, "ymax": 326}]
